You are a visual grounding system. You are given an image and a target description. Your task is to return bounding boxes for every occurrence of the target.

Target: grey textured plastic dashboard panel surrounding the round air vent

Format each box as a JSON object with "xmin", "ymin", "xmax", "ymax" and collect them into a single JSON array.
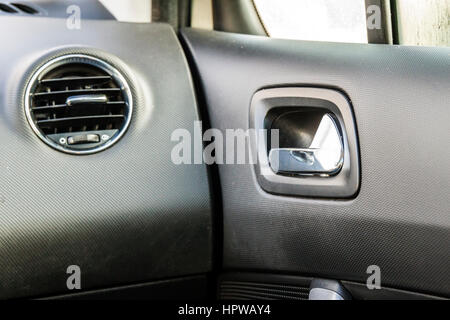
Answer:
[{"xmin": 0, "ymin": 17, "xmax": 212, "ymax": 298}]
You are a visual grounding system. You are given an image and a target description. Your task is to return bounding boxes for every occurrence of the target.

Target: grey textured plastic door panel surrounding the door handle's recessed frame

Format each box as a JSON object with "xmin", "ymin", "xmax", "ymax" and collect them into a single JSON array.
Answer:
[{"xmin": 183, "ymin": 29, "xmax": 450, "ymax": 296}]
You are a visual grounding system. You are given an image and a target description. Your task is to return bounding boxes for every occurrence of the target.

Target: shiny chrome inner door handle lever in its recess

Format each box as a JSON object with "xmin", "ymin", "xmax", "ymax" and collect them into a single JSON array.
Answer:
[{"xmin": 269, "ymin": 114, "xmax": 344, "ymax": 177}]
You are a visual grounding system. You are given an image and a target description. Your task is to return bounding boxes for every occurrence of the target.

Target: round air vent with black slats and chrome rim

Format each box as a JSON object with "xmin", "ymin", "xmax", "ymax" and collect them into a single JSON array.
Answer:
[{"xmin": 25, "ymin": 54, "xmax": 133, "ymax": 154}]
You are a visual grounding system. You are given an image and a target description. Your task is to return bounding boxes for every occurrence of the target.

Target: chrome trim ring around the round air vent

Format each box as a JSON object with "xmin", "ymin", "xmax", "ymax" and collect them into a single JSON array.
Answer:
[{"xmin": 24, "ymin": 54, "xmax": 133, "ymax": 155}]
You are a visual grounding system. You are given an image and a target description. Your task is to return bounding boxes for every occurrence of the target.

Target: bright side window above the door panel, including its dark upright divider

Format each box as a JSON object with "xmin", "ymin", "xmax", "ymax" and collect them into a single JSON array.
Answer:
[{"xmin": 253, "ymin": 0, "xmax": 450, "ymax": 46}]
